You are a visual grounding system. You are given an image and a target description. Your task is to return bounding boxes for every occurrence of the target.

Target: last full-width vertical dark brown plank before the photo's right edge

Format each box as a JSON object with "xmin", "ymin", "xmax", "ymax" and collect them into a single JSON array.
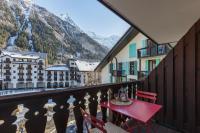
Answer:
[{"xmin": 184, "ymin": 27, "xmax": 196, "ymax": 132}]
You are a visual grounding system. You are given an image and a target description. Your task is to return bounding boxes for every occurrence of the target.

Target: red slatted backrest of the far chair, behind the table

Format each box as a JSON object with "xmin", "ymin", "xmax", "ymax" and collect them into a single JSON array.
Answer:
[{"xmin": 135, "ymin": 90, "xmax": 157, "ymax": 103}]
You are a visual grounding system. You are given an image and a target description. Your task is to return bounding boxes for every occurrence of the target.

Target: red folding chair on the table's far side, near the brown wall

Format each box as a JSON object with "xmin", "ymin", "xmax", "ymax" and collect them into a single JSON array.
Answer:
[{"xmin": 122, "ymin": 90, "xmax": 157, "ymax": 132}]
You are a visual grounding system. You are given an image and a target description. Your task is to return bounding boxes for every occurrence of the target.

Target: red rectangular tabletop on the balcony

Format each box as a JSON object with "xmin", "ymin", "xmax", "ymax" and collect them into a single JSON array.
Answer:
[{"xmin": 100, "ymin": 99, "xmax": 162, "ymax": 123}]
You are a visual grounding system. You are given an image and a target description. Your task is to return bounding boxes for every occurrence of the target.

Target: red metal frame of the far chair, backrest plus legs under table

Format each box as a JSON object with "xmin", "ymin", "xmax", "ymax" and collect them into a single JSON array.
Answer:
[{"xmin": 125, "ymin": 90, "xmax": 157, "ymax": 133}]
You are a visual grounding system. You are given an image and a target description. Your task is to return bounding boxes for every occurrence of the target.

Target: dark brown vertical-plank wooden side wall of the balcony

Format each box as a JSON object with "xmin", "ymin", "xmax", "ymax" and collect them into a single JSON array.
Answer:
[{"xmin": 143, "ymin": 20, "xmax": 200, "ymax": 133}]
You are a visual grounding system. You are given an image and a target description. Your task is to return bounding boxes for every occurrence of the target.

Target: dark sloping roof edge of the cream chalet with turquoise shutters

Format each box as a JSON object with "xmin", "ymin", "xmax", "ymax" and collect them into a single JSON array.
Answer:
[{"xmin": 95, "ymin": 27, "xmax": 139, "ymax": 71}]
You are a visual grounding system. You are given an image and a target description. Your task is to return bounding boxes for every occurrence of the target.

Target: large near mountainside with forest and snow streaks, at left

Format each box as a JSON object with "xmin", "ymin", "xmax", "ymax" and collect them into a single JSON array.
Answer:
[{"xmin": 0, "ymin": 0, "xmax": 108, "ymax": 63}]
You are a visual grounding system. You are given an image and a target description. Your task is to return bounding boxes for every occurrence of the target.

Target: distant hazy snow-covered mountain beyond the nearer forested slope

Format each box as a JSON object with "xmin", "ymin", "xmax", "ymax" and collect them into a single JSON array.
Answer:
[{"xmin": 86, "ymin": 31, "xmax": 120, "ymax": 49}]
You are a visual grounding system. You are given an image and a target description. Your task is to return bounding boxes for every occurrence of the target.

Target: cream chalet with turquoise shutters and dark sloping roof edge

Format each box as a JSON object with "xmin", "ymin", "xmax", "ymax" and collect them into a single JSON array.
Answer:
[{"xmin": 95, "ymin": 28, "xmax": 170, "ymax": 83}]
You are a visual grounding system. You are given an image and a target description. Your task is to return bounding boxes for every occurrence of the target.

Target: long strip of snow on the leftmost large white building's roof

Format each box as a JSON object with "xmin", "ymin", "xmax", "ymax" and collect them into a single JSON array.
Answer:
[{"xmin": 2, "ymin": 51, "xmax": 40, "ymax": 59}]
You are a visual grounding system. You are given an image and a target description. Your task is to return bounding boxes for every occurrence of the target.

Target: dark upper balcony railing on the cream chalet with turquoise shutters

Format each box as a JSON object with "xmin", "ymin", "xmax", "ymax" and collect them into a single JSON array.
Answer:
[{"xmin": 137, "ymin": 44, "xmax": 170, "ymax": 58}]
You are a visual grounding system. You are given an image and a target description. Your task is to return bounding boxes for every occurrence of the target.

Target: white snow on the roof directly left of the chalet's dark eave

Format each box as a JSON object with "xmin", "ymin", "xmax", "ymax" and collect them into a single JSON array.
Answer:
[{"xmin": 75, "ymin": 60, "xmax": 99, "ymax": 72}]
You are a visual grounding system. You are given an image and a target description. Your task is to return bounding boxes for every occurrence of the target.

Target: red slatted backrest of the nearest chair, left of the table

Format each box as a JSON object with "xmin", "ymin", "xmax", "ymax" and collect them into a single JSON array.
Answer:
[{"xmin": 80, "ymin": 108, "xmax": 107, "ymax": 133}]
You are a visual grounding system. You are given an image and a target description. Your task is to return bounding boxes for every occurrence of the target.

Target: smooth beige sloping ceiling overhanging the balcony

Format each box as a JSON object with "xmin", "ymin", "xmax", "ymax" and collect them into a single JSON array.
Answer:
[{"xmin": 101, "ymin": 0, "xmax": 200, "ymax": 43}]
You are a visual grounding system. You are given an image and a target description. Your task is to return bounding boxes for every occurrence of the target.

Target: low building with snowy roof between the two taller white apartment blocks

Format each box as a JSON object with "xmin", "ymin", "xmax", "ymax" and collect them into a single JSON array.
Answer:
[{"xmin": 45, "ymin": 65, "xmax": 70, "ymax": 88}]
